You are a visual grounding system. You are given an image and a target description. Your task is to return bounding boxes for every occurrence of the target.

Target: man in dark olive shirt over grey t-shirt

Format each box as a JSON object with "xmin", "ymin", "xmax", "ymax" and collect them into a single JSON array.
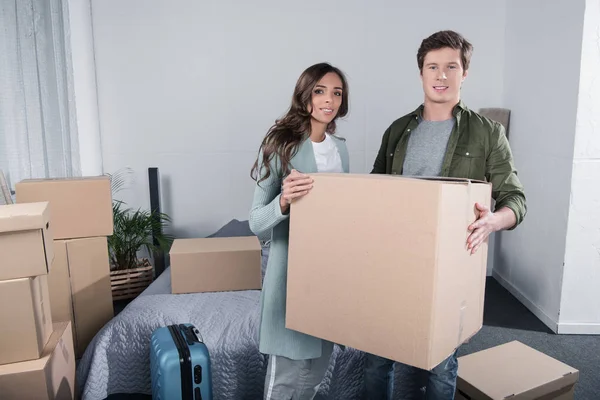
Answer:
[{"xmin": 365, "ymin": 31, "xmax": 526, "ymax": 400}]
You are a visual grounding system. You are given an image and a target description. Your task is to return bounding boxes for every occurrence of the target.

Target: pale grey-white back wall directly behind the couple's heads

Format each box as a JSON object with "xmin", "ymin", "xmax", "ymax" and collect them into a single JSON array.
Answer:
[{"xmin": 92, "ymin": 0, "xmax": 506, "ymax": 237}]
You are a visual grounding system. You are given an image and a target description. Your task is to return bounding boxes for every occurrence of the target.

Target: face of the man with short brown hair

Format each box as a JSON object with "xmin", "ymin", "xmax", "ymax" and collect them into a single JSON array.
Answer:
[{"xmin": 421, "ymin": 47, "xmax": 467, "ymax": 104}]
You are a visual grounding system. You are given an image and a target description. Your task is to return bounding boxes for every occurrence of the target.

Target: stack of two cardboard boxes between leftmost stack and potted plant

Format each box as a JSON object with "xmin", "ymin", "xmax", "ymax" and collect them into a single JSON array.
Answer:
[{"xmin": 15, "ymin": 176, "xmax": 114, "ymax": 357}]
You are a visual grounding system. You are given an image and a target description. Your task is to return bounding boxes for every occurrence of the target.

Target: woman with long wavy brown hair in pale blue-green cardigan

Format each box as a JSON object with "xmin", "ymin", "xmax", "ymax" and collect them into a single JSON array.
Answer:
[{"xmin": 250, "ymin": 63, "xmax": 349, "ymax": 400}]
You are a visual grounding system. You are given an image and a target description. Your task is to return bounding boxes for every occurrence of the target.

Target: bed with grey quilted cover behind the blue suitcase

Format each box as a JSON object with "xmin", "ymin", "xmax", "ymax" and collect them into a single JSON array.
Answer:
[{"xmin": 77, "ymin": 220, "xmax": 364, "ymax": 400}]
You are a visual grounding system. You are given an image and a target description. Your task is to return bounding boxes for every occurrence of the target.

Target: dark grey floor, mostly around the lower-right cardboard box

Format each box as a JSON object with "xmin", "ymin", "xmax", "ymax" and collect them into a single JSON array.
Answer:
[{"xmin": 107, "ymin": 277, "xmax": 600, "ymax": 400}]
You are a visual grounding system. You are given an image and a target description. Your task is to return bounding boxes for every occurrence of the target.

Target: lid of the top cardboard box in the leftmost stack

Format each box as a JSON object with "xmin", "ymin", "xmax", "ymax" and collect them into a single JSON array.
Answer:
[{"xmin": 0, "ymin": 201, "xmax": 50, "ymax": 233}]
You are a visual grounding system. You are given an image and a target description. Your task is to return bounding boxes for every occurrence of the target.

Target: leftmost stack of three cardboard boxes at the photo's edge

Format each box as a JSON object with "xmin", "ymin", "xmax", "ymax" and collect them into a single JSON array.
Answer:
[{"xmin": 0, "ymin": 202, "xmax": 75, "ymax": 400}]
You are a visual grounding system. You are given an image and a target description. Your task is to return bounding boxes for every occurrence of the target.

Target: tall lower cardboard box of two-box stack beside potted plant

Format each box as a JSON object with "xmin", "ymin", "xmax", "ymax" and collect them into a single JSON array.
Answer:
[{"xmin": 49, "ymin": 237, "xmax": 114, "ymax": 357}]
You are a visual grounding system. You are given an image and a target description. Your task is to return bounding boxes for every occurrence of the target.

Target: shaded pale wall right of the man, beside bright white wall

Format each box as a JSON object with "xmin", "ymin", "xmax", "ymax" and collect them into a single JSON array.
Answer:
[{"xmin": 494, "ymin": 0, "xmax": 585, "ymax": 330}]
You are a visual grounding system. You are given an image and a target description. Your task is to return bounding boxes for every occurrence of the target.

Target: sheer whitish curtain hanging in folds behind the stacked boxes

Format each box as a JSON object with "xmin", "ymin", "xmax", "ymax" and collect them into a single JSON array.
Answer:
[{"xmin": 0, "ymin": 0, "xmax": 80, "ymax": 192}]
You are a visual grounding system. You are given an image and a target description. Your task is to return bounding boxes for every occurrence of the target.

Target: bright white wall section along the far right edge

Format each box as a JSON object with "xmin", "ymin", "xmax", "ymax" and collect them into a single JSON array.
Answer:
[{"xmin": 559, "ymin": 0, "xmax": 600, "ymax": 334}]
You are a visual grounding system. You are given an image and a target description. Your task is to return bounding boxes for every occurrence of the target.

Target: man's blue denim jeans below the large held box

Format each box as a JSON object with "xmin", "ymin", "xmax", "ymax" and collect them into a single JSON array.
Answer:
[{"xmin": 365, "ymin": 350, "xmax": 458, "ymax": 400}]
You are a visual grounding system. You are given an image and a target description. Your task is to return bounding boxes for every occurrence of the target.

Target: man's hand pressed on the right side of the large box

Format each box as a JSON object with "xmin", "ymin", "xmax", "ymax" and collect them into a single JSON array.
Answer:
[{"xmin": 467, "ymin": 203, "xmax": 517, "ymax": 254}]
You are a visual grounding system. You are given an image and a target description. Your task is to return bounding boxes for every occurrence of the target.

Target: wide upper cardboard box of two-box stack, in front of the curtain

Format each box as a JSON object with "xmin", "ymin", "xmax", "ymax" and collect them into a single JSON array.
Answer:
[{"xmin": 15, "ymin": 176, "xmax": 113, "ymax": 239}]
